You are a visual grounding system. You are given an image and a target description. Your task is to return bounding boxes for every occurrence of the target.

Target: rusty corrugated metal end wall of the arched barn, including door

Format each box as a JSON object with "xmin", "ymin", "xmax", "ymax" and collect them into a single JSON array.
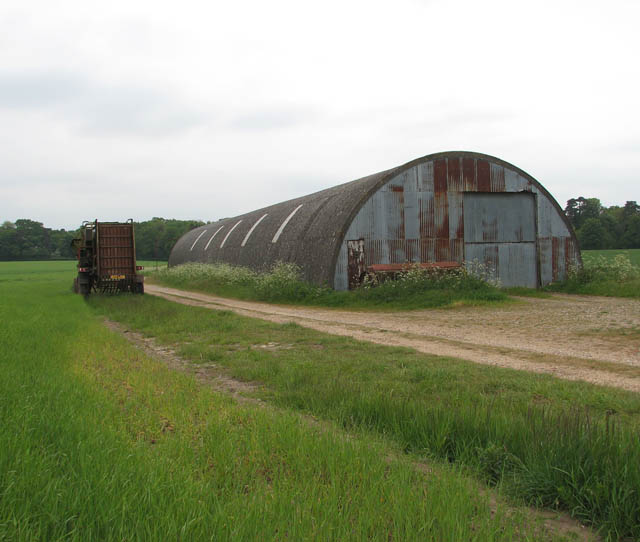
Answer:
[{"xmin": 334, "ymin": 156, "xmax": 578, "ymax": 289}]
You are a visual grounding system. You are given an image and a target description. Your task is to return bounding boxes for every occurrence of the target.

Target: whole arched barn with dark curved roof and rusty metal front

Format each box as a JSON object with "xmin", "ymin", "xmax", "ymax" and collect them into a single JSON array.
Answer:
[{"xmin": 169, "ymin": 151, "xmax": 580, "ymax": 290}]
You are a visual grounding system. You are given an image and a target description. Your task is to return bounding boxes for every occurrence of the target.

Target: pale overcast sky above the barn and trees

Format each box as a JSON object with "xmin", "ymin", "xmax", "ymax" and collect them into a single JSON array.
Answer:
[{"xmin": 0, "ymin": 0, "xmax": 640, "ymax": 229}]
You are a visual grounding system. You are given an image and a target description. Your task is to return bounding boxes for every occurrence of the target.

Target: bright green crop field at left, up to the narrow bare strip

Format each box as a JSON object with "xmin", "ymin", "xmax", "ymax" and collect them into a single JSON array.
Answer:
[{"xmin": 0, "ymin": 262, "xmax": 543, "ymax": 542}]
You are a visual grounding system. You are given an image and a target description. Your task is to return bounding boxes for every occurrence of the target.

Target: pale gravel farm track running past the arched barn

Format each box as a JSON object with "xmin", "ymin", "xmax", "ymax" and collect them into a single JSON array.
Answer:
[{"xmin": 145, "ymin": 284, "xmax": 640, "ymax": 391}]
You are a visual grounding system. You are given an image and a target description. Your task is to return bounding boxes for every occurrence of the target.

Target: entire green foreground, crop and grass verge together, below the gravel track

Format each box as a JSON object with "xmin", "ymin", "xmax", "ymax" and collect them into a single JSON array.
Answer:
[{"xmin": 0, "ymin": 262, "xmax": 640, "ymax": 541}]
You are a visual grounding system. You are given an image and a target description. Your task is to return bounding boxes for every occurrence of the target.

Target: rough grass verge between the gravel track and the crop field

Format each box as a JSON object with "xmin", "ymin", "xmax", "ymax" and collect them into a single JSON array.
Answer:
[{"xmin": 91, "ymin": 297, "xmax": 640, "ymax": 539}]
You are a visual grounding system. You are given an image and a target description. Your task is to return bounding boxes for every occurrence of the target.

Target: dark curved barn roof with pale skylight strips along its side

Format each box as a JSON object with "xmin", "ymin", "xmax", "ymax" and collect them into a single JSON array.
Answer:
[{"xmin": 169, "ymin": 151, "xmax": 577, "ymax": 285}]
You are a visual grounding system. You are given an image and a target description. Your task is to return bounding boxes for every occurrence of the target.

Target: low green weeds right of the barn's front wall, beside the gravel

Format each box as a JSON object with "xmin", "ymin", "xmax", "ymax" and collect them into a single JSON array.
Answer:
[{"xmin": 547, "ymin": 250, "xmax": 640, "ymax": 297}]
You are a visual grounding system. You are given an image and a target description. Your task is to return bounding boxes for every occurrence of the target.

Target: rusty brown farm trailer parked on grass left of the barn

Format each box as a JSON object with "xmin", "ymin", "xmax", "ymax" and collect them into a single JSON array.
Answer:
[{"xmin": 71, "ymin": 219, "xmax": 144, "ymax": 295}]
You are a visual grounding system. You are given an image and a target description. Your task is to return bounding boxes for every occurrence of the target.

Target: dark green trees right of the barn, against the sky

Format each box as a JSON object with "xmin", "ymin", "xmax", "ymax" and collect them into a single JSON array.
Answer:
[{"xmin": 564, "ymin": 200, "xmax": 640, "ymax": 250}]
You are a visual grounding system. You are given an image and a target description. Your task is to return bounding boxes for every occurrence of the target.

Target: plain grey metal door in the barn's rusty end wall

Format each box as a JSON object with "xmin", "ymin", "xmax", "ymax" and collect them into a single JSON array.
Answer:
[{"xmin": 463, "ymin": 192, "xmax": 539, "ymax": 288}]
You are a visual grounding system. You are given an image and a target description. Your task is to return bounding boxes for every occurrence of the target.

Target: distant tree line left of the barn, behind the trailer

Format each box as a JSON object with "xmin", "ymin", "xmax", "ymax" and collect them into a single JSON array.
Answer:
[{"xmin": 0, "ymin": 217, "xmax": 204, "ymax": 261}]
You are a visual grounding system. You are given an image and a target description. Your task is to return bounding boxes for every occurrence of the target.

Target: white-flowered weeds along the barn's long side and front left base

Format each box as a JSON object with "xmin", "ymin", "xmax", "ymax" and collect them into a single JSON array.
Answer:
[{"xmin": 153, "ymin": 263, "xmax": 507, "ymax": 309}]
